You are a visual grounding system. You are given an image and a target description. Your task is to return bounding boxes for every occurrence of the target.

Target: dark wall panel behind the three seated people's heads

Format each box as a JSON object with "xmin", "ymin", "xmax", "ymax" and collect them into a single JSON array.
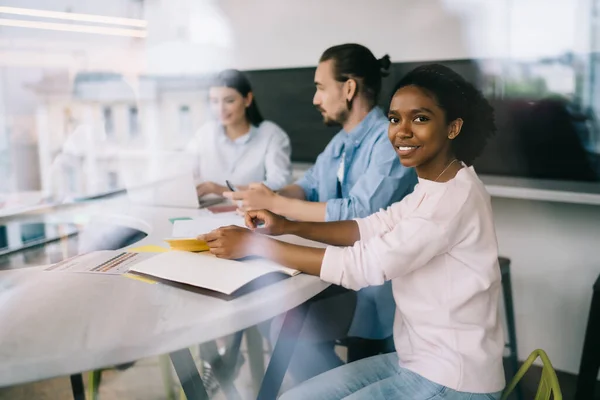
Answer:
[{"xmin": 248, "ymin": 60, "xmax": 600, "ymax": 181}]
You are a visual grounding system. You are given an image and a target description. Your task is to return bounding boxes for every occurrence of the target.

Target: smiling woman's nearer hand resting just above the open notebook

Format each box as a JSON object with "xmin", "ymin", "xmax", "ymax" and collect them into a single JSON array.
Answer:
[{"xmin": 198, "ymin": 226, "xmax": 265, "ymax": 260}]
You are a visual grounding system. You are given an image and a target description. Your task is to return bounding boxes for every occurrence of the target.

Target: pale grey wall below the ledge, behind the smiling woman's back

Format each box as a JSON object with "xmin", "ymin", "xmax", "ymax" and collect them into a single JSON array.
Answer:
[{"xmin": 492, "ymin": 198, "xmax": 600, "ymax": 373}]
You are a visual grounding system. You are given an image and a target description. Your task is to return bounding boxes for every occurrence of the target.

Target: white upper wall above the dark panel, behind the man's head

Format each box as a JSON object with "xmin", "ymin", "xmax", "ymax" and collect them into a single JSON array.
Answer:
[{"xmin": 218, "ymin": 0, "xmax": 590, "ymax": 69}]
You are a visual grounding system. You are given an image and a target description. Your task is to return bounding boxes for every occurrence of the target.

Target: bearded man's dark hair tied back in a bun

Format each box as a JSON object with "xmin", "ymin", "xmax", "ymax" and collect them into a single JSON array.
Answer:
[{"xmin": 319, "ymin": 43, "xmax": 391, "ymax": 104}]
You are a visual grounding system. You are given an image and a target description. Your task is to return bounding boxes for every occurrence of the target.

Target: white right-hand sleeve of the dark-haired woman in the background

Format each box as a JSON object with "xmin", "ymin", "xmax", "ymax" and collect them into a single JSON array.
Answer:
[{"xmin": 263, "ymin": 126, "xmax": 292, "ymax": 190}]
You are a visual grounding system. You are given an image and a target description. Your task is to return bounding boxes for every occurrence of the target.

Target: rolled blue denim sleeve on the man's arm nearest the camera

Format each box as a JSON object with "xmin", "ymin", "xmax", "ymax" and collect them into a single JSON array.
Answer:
[{"xmin": 325, "ymin": 143, "xmax": 417, "ymax": 221}]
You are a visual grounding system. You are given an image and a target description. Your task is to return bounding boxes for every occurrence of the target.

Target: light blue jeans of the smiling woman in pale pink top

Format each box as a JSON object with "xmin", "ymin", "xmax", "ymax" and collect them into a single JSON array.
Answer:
[{"xmin": 280, "ymin": 353, "xmax": 502, "ymax": 400}]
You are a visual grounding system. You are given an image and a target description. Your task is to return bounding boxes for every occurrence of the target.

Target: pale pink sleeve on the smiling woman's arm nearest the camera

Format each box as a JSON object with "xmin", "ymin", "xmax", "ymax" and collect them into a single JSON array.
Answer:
[{"xmin": 321, "ymin": 218, "xmax": 448, "ymax": 290}]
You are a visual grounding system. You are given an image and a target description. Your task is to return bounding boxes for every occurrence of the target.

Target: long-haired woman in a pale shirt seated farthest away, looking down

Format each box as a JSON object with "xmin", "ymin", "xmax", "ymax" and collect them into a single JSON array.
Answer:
[{"xmin": 187, "ymin": 69, "xmax": 292, "ymax": 196}]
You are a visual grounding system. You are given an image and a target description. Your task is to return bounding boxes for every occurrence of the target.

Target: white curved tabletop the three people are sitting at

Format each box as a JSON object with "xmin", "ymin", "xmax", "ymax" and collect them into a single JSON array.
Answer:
[{"xmin": 0, "ymin": 202, "xmax": 329, "ymax": 398}]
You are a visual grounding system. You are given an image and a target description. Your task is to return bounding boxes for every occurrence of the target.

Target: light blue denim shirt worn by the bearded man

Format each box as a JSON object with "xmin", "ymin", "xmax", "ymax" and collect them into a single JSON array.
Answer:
[{"xmin": 296, "ymin": 107, "xmax": 417, "ymax": 339}]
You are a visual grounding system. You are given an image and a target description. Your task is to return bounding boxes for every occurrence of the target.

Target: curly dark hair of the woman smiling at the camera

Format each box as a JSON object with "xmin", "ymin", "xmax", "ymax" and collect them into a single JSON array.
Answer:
[{"xmin": 392, "ymin": 64, "xmax": 496, "ymax": 165}]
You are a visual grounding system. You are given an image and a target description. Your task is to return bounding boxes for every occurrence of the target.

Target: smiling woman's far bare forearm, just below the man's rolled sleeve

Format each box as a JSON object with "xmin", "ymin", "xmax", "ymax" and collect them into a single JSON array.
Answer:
[{"xmin": 285, "ymin": 217, "xmax": 360, "ymax": 246}]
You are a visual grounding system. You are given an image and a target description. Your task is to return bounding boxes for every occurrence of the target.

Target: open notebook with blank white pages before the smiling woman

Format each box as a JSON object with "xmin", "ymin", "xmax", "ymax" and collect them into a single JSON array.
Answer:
[{"xmin": 129, "ymin": 251, "xmax": 300, "ymax": 296}]
